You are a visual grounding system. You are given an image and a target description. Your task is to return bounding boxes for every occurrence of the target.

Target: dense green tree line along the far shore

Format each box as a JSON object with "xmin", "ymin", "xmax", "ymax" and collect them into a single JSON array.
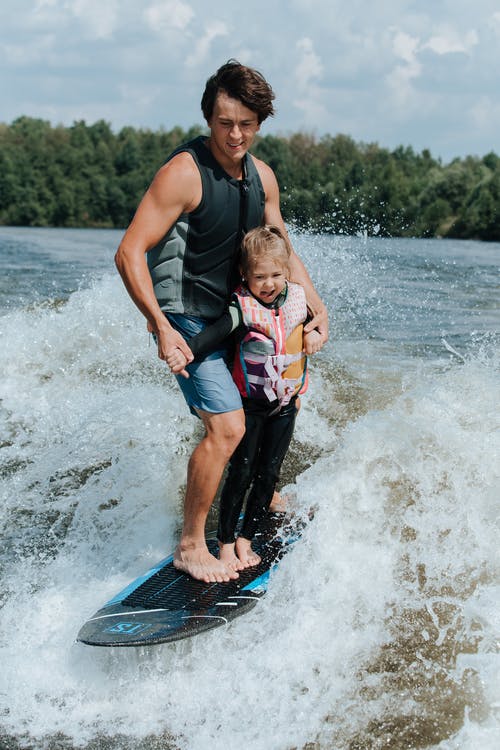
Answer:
[{"xmin": 0, "ymin": 116, "xmax": 500, "ymax": 241}]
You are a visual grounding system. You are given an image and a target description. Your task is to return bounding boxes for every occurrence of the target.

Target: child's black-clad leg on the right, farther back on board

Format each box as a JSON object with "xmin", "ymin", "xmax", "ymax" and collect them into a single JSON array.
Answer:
[{"xmin": 236, "ymin": 401, "xmax": 297, "ymax": 552}]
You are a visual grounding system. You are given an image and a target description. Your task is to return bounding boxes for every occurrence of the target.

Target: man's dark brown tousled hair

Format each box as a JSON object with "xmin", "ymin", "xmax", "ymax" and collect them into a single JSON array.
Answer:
[{"xmin": 201, "ymin": 60, "xmax": 275, "ymax": 125}]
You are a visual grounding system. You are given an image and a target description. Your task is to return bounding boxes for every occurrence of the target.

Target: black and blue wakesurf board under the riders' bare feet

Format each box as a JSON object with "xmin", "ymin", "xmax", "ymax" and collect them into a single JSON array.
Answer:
[{"xmin": 77, "ymin": 513, "xmax": 305, "ymax": 646}]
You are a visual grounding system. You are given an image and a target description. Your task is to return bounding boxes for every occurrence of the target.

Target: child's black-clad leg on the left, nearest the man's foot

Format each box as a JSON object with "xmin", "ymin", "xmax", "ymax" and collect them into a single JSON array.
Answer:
[{"xmin": 217, "ymin": 413, "xmax": 265, "ymax": 570}]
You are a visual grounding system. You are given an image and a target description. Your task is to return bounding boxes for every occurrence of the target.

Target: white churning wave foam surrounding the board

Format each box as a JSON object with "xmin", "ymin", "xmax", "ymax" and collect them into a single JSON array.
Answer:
[{"xmin": 0, "ymin": 268, "xmax": 500, "ymax": 750}]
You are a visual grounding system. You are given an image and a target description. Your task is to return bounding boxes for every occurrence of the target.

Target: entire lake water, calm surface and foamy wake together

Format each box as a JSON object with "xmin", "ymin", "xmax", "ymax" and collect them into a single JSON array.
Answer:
[{"xmin": 0, "ymin": 227, "xmax": 500, "ymax": 750}]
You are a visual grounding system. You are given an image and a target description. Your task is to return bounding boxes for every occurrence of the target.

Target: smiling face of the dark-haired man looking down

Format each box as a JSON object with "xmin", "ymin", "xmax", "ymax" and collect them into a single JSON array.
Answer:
[{"xmin": 208, "ymin": 91, "xmax": 260, "ymax": 166}]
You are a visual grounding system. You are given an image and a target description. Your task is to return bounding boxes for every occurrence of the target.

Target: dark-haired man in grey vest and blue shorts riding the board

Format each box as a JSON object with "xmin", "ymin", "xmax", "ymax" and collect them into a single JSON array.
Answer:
[{"xmin": 115, "ymin": 60, "xmax": 328, "ymax": 583}]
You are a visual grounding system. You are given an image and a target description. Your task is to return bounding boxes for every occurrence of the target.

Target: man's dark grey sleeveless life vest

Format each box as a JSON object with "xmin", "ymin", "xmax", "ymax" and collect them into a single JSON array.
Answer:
[{"xmin": 147, "ymin": 136, "xmax": 265, "ymax": 320}]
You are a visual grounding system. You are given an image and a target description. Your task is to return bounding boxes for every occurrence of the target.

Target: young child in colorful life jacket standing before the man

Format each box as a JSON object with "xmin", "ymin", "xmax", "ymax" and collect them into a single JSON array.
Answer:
[{"xmin": 166, "ymin": 225, "xmax": 321, "ymax": 571}]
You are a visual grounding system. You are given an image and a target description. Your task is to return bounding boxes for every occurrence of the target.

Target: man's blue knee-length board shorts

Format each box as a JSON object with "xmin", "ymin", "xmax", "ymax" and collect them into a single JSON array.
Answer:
[{"xmin": 166, "ymin": 313, "xmax": 242, "ymax": 416}]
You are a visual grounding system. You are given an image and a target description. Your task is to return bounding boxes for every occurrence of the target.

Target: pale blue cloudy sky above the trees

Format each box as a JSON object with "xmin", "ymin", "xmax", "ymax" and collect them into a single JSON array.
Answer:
[{"xmin": 0, "ymin": 0, "xmax": 500, "ymax": 163}]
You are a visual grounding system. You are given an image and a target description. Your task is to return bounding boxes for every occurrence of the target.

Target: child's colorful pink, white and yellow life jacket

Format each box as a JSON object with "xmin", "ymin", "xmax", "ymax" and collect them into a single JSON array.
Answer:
[{"xmin": 233, "ymin": 282, "xmax": 307, "ymax": 406}]
